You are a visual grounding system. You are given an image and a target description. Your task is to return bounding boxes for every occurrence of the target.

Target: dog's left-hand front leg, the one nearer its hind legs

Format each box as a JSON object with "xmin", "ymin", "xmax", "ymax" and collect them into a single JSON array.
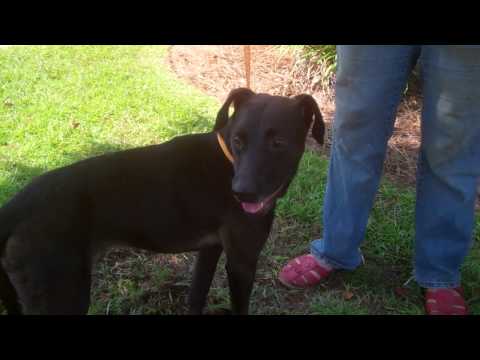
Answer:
[{"xmin": 188, "ymin": 245, "xmax": 223, "ymax": 315}]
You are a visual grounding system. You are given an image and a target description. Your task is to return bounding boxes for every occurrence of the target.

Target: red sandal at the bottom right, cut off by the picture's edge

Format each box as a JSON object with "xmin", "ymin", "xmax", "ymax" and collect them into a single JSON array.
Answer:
[{"xmin": 425, "ymin": 288, "xmax": 468, "ymax": 315}]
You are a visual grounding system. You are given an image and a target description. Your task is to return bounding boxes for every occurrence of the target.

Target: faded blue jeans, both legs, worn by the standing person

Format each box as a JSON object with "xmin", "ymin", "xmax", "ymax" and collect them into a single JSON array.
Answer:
[{"xmin": 311, "ymin": 45, "xmax": 480, "ymax": 288}]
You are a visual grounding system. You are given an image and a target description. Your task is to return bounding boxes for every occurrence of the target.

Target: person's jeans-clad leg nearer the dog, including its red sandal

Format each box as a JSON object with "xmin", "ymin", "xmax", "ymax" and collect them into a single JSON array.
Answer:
[{"xmin": 280, "ymin": 45, "xmax": 420, "ymax": 286}]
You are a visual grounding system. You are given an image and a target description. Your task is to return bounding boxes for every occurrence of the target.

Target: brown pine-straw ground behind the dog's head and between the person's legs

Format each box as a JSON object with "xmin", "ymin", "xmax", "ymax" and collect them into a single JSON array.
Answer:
[{"xmin": 167, "ymin": 45, "xmax": 480, "ymax": 209}]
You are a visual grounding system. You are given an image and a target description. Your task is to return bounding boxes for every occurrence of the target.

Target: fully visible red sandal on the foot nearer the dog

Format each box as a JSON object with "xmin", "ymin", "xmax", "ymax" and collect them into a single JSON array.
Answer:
[{"xmin": 278, "ymin": 254, "xmax": 334, "ymax": 289}]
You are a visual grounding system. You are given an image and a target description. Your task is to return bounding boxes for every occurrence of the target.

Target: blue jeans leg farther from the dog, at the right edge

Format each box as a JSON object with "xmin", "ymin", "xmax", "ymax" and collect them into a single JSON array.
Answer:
[{"xmin": 415, "ymin": 46, "xmax": 480, "ymax": 288}]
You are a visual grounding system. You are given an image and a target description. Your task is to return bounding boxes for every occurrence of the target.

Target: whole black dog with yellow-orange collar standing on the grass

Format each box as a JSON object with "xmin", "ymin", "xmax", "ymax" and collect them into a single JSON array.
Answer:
[{"xmin": 0, "ymin": 89, "xmax": 324, "ymax": 314}]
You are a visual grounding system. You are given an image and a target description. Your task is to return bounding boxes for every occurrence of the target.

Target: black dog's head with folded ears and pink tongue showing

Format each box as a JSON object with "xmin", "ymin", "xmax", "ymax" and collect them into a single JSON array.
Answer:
[{"xmin": 214, "ymin": 88, "xmax": 325, "ymax": 214}]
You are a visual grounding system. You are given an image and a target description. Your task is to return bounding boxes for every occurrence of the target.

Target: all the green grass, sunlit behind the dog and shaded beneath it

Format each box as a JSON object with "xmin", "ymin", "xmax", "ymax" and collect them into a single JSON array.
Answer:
[{"xmin": 0, "ymin": 46, "xmax": 480, "ymax": 314}]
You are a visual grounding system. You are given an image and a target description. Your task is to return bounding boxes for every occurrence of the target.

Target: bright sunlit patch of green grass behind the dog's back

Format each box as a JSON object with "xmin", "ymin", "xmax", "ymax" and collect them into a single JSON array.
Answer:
[{"xmin": 0, "ymin": 46, "xmax": 218, "ymax": 202}]
